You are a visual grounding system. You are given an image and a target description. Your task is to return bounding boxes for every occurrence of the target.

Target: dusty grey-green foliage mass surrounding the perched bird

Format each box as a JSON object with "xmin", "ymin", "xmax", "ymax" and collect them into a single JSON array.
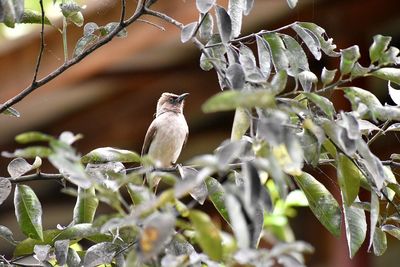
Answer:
[{"xmin": 0, "ymin": 0, "xmax": 400, "ymax": 266}]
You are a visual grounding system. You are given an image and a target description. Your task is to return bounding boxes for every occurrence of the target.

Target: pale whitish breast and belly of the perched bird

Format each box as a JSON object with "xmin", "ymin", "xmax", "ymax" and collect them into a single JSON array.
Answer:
[{"xmin": 148, "ymin": 112, "xmax": 189, "ymax": 167}]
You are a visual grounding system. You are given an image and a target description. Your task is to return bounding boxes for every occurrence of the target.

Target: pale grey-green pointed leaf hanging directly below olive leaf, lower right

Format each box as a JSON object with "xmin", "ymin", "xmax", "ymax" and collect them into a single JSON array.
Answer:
[{"xmin": 343, "ymin": 199, "xmax": 367, "ymax": 258}]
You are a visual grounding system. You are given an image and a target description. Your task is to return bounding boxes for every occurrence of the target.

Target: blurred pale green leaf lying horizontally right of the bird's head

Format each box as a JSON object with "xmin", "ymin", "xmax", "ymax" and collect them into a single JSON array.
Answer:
[{"xmin": 202, "ymin": 90, "xmax": 275, "ymax": 113}]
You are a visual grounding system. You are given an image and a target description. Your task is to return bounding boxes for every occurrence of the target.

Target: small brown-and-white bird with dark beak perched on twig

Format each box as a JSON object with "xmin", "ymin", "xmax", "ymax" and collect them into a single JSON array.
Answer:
[{"xmin": 141, "ymin": 92, "xmax": 189, "ymax": 188}]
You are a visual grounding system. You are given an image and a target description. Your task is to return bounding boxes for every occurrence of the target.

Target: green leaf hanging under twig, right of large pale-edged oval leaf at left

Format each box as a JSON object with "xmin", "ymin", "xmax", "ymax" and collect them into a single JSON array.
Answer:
[{"xmin": 73, "ymin": 187, "xmax": 99, "ymax": 224}]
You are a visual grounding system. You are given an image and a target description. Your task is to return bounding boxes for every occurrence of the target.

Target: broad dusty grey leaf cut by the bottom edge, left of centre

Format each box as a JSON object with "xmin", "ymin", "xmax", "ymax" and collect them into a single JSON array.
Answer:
[{"xmin": 83, "ymin": 242, "xmax": 120, "ymax": 267}]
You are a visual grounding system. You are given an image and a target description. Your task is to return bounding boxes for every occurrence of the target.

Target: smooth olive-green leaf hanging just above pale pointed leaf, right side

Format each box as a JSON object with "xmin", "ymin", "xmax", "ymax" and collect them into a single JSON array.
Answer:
[{"xmin": 337, "ymin": 154, "xmax": 362, "ymax": 206}]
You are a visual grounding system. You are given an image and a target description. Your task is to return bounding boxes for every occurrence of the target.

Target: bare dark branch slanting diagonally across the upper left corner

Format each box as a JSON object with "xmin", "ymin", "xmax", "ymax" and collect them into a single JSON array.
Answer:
[{"xmin": 0, "ymin": 1, "xmax": 144, "ymax": 113}]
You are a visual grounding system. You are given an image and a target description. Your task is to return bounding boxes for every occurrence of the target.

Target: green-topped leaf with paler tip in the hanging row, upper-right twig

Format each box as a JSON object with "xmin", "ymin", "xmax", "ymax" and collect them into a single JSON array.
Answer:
[{"xmin": 263, "ymin": 33, "xmax": 289, "ymax": 72}]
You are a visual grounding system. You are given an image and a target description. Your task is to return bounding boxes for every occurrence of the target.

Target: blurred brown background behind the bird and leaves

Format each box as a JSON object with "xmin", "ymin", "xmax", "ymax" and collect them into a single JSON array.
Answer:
[{"xmin": 0, "ymin": 0, "xmax": 400, "ymax": 267}]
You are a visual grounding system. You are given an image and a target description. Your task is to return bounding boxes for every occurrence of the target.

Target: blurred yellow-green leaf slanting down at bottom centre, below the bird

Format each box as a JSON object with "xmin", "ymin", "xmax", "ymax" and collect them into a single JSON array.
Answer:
[{"xmin": 189, "ymin": 210, "xmax": 222, "ymax": 261}]
